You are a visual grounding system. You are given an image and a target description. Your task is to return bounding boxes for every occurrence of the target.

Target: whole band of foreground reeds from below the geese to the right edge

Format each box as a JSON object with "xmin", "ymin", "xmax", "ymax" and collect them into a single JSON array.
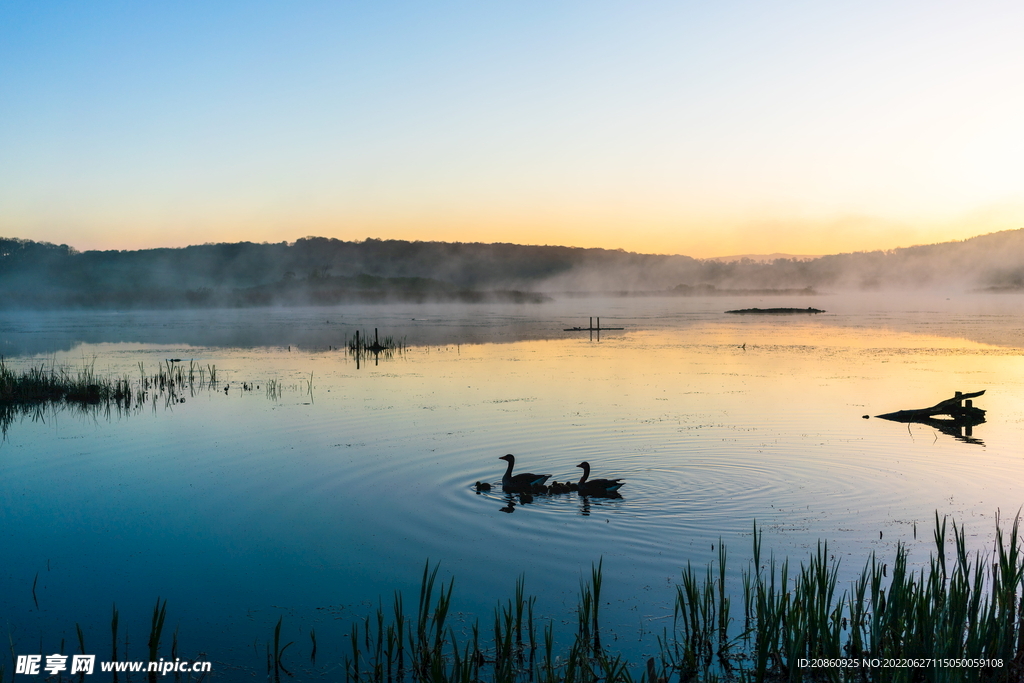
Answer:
[{"xmin": 337, "ymin": 515, "xmax": 1024, "ymax": 683}]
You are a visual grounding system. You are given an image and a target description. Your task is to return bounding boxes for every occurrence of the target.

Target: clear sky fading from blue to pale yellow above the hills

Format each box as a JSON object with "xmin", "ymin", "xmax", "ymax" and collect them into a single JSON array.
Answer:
[{"xmin": 0, "ymin": 0, "xmax": 1024, "ymax": 258}]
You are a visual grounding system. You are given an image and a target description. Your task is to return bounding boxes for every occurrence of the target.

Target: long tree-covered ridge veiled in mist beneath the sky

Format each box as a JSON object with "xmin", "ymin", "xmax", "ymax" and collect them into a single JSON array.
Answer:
[{"xmin": 0, "ymin": 230, "xmax": 1024, "ymax": 307}]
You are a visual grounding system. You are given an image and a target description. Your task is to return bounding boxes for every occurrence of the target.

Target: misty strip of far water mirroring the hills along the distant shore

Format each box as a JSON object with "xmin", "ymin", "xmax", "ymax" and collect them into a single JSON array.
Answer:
[{"xmin": 6, "ymin": 292, "xmax": 1024, "ymax": 361}]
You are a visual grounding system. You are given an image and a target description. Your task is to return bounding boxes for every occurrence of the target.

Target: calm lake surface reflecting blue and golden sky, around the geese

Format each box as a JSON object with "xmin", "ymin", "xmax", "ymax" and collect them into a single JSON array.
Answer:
[{"xmin": 0, "ymin": 296, "xmax": 1024, "ymax": 677}]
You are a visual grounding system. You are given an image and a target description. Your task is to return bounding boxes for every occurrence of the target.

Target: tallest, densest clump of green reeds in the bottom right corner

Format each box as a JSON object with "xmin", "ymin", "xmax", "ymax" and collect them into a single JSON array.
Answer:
[{"xmin": 659, "ymin": 514, "xmax": 1024, "ymax": 681}]
